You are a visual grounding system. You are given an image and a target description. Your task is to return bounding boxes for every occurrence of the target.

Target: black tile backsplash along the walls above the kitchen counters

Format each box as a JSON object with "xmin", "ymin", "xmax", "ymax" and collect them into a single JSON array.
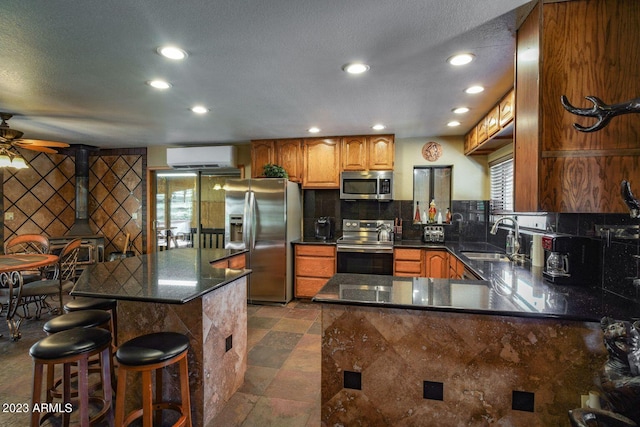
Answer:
[{"xmin": 303, "ymin": 190, "xmax": 640, "ymax": 302}]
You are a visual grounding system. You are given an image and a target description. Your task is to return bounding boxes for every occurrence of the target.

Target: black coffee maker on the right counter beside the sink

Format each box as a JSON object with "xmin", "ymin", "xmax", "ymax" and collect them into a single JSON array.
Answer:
[{"xmin": 542, "ymin": 234, "xmax": 600, "ymax": 285}]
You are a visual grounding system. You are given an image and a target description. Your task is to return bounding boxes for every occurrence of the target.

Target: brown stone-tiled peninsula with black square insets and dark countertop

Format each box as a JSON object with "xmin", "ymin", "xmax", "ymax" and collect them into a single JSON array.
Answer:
[{"xmin": 313, "ymin": 274, "xmax": 606, "ymax": 426}]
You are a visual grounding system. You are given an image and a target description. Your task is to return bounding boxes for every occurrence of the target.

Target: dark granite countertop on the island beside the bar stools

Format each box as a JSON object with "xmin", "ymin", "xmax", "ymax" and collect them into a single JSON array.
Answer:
[{"xmin": 71, "ymin": 248, "xmax": 251, "ymax": 304}]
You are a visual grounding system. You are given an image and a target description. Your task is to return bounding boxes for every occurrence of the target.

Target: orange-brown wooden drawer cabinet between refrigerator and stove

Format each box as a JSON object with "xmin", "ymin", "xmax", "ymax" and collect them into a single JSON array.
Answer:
[{"xmin": 294, "ymin": 245, "xmax": 336, "ymax": 298}]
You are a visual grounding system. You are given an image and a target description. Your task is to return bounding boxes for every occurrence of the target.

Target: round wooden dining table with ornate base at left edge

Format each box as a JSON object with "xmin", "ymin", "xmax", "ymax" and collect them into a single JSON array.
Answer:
[{"xmin": 0, "ymin": 254, "xmax": 58, "ymax": 341}]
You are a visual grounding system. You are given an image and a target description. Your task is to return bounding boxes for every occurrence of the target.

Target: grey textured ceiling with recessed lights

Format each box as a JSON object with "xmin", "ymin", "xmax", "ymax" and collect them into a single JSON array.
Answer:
[{"xmin": 0, "ymin": 0, "xmax": 529, "ymax": 148}]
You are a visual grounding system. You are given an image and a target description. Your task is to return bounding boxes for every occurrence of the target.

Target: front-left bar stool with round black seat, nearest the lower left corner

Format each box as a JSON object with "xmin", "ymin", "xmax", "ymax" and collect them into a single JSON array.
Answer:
[{"xmin": 29, "ymin": 328, "xmax": 113, "ymax": 427}]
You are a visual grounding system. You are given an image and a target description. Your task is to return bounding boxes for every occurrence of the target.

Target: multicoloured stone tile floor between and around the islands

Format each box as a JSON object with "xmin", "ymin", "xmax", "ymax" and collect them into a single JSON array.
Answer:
[{"xmin": 0, "ymin": 301, "xmax": 321, "ymax": 427}]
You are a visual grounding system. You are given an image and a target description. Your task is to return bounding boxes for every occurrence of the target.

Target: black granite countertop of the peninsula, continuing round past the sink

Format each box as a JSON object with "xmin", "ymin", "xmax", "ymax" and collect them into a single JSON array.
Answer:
[{"xmin": 313, "ymin": 241, "xmax": 640, "ymax": 322}]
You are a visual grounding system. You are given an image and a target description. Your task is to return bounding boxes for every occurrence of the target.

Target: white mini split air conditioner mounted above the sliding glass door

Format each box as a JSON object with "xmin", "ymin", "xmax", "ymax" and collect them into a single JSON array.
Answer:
[{"xmin": 167, "ymin": 145, "xmax": 236, "ymax": 169}]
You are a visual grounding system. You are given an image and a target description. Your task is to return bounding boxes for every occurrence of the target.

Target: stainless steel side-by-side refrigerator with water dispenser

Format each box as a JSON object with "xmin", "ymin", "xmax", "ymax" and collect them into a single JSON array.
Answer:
[{"xmin": 224, "ymin": 178, "xmax": 302, "ymax": 304}]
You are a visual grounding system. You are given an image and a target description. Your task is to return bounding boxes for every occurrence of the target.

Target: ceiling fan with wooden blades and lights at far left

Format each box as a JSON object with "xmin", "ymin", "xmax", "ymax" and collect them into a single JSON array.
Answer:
[{"xmin": 0, "ymin": 112, "xmax": 69, "ymax": 169}]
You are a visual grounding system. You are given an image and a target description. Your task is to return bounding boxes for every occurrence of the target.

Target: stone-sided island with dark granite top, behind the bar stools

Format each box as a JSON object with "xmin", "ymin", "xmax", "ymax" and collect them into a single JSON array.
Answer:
[{"xmin": 71, "ymin": 248, "xmax": 251, "ymax": 426}]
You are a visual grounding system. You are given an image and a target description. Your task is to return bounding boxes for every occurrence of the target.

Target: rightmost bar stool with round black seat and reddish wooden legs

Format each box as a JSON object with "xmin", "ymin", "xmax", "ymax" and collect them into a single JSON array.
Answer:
[{"xmin": 115, "ymin": 332, "xmax": 191, "ymax": 427}]
